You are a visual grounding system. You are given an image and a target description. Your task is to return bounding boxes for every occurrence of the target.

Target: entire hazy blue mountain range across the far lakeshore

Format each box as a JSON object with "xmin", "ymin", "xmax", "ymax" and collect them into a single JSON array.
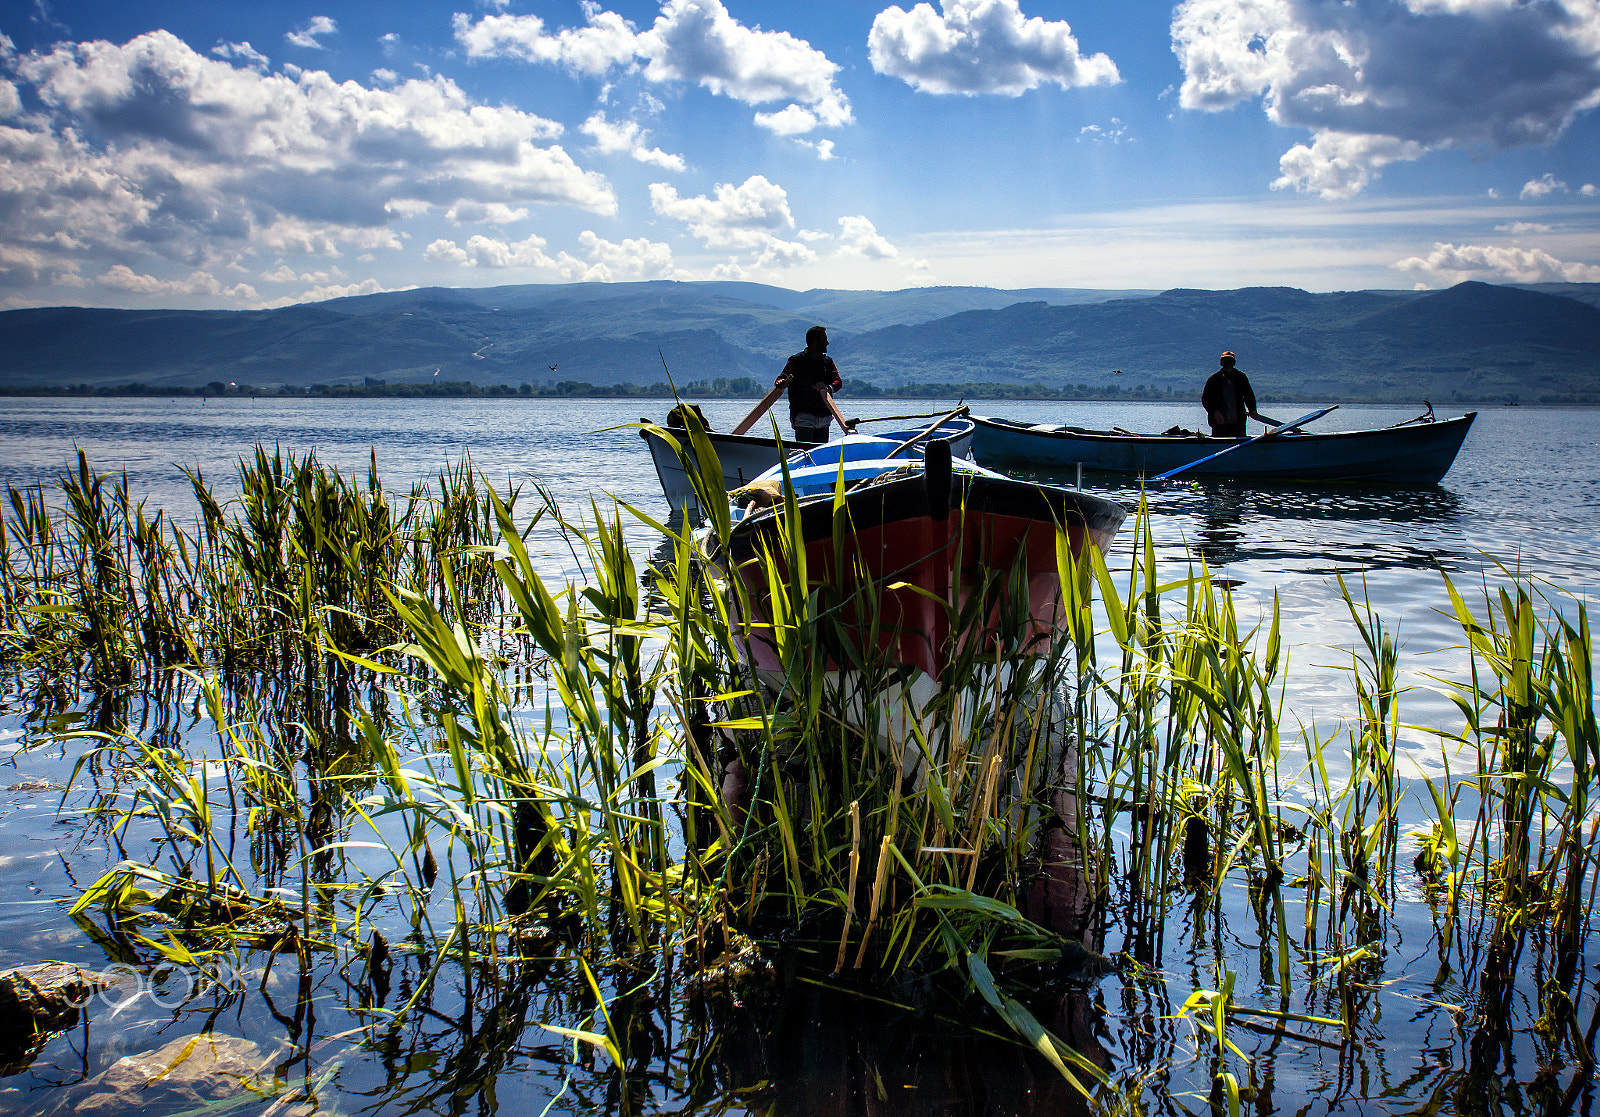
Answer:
[{"xmin": 0, "ymin": 282, "xmax": 1600, "ymax": 402}]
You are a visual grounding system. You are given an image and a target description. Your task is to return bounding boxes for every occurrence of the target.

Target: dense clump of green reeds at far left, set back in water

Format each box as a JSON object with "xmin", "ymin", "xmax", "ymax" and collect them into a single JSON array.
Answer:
[{"xmin": 0, "ymin": 446, "xmax": 512, "ymax": 687}]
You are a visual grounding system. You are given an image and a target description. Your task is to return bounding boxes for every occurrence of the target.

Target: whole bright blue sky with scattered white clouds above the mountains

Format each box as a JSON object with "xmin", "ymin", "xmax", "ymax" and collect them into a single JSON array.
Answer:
[{"xmin": 0, "ymin": 0, "xmax": 1600, "ymax": 309}]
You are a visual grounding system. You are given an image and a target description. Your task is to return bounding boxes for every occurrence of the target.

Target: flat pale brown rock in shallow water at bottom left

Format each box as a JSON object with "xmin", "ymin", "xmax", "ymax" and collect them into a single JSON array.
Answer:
[{"xmin": 53, "ymin": 1034, "xmax": 267, "ymax": 1117}]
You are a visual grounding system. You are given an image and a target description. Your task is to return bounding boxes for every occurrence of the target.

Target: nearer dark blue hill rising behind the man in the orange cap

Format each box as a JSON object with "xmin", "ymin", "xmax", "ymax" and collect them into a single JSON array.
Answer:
[{"xmin": 838, "ymin": 283, "xmax": 1600, "ymax": 400}]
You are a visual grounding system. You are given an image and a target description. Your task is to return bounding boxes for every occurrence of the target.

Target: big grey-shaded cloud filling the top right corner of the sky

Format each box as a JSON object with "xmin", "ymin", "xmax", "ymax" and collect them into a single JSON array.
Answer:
[{"xmin": 1171, "ymin": 0, "xmax": 1600, "ymax": 198}]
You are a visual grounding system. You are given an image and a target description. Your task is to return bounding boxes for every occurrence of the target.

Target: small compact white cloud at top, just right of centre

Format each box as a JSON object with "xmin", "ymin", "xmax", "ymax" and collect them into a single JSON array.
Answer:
[{"xmin": 867, "ymin": 0, "xmax": 1122, "ymax": 98}]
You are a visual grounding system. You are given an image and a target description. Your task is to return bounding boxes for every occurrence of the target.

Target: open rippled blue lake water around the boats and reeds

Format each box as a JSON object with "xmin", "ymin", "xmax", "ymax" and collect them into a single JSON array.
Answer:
[{"xmin": 0, "ymin": 398, "xmax": 1600, "ymax": 1114}]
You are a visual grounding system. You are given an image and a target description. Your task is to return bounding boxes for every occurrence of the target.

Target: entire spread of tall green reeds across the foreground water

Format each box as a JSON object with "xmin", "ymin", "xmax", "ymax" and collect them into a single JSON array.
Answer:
[{"xmin": 0, "ymin": 438, "xmax": 1600, "ymax": 1111}]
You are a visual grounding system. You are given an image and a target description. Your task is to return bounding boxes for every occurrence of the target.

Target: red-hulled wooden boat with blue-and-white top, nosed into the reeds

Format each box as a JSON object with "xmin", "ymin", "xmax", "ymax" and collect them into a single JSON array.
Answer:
[{"xmin": 712, "ymin": 440, "xmax": 1126, "ymax": 688}]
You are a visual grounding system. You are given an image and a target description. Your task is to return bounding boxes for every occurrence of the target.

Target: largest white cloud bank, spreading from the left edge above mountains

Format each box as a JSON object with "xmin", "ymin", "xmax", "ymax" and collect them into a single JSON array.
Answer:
[{"xmin": 0, "ymin": 32, "xmax": 616, "ymax": 300}]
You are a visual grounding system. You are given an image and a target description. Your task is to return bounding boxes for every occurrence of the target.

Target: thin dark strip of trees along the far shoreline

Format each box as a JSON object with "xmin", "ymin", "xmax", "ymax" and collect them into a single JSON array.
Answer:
[{"xmin": 0, "ymin": 376, "xmax": 1548, "ymax": 405}]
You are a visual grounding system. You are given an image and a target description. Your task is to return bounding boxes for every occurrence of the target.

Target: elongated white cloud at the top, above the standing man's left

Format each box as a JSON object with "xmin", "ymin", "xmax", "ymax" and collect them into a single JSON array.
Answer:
[{"xmin": 453, "ymin": 0, "xmax": 854, "ymax": 134}]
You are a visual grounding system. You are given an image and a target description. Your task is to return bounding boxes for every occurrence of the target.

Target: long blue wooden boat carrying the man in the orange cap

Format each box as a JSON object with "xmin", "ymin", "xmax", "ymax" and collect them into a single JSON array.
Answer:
[{"xmin": 973, "ymin": 408, "xmax": 1477, "ymax": 485}]
